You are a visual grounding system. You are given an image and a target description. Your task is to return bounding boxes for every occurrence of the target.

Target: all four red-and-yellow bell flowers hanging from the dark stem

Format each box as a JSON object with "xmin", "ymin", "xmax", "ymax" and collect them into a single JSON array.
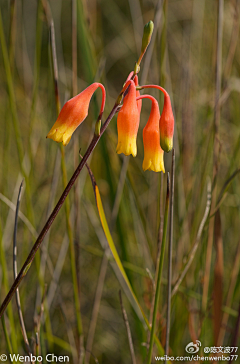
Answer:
[{"xmin": 47, "ymin": 72, "xmax": 174, "ymax": 172}]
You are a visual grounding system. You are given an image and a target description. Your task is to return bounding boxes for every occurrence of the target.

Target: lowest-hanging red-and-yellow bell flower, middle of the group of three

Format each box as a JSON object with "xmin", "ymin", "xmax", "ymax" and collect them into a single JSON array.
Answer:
[{"xmin": 137, "ymin": 95, "xmax": 165, "ymax": 173}]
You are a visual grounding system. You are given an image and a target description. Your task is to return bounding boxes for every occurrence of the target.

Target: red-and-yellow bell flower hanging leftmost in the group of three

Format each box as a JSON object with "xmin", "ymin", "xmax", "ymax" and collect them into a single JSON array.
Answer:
[{"xmin": 116, "ymin": 80, "xmax": 140, "ymax": 157}]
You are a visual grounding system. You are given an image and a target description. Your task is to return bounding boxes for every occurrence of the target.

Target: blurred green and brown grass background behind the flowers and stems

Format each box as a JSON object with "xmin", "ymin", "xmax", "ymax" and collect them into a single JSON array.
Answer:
[{"xmin": 0, "ymin": 0, "xmax": 240, "ymax": 363}]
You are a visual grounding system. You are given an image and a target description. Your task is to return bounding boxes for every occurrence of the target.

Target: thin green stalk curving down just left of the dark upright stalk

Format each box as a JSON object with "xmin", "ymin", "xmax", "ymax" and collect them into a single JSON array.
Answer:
[{"xmin": 147, "ymin": 173, "xmax": 170, "ymax": 364}]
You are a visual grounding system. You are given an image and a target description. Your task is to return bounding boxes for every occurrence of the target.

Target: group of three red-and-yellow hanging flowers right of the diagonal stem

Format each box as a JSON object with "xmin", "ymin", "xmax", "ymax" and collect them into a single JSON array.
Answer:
[{"xmin": 117, "ymin": 74, "xmax": 174, "ymax": 172}]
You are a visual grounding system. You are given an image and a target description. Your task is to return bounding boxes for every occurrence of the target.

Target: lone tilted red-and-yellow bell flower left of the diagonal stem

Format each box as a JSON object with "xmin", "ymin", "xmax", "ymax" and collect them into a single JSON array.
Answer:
[{"xmin": 47, "ymin": 82, "xmax": 106, "ymax": 145}]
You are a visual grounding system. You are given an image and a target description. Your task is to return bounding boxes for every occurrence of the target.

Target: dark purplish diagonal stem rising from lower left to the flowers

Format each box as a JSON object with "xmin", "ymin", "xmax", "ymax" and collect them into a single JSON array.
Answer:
[{"xmin": 0, "ymin": 102, "xmax": 119, "ymax": 318}]
